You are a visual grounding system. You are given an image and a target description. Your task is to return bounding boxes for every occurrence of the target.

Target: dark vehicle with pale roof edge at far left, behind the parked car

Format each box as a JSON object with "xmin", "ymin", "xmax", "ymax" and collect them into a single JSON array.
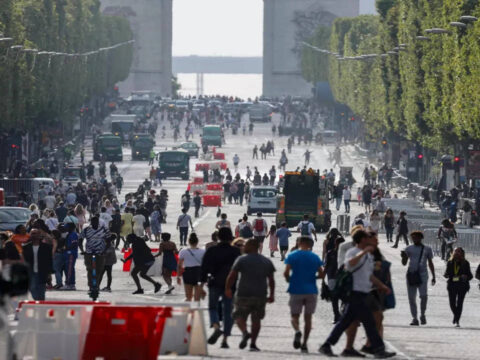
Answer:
[{"xmin": 0, "ymin": 178, "xmax": 55, "ymax": 206}]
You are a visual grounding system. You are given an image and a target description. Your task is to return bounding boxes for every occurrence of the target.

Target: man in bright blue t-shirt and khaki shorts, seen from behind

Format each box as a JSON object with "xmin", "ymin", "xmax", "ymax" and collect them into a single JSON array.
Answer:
[{"xmin": 284, "ymin": 236, "xmax": 324, "ymax": 353}]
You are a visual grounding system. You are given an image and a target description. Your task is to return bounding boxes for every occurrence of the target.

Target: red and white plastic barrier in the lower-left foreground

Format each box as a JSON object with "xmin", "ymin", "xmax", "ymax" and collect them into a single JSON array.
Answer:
[{"xmin": 14, "ymin": 302, "xmax": 208, "ymax": 360}]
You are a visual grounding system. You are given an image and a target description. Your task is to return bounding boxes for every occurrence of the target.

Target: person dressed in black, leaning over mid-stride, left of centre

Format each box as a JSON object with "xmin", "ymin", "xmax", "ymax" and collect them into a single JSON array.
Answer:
[{"xmin": 122, "ymin": 234, "xmax": 162, "ymax": 295}]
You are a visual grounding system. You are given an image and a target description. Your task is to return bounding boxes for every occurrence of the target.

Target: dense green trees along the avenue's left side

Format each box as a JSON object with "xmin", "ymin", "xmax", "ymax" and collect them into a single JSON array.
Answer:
[{"xmin": 0, "ymin": 0, "xmax": 133, "ymax": 129}]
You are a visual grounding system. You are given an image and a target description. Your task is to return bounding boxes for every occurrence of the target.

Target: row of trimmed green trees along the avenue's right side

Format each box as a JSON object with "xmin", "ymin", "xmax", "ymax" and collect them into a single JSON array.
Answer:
[{"xmin": 302, "ymin": 0, "xmax": 480, "ymax": 151}]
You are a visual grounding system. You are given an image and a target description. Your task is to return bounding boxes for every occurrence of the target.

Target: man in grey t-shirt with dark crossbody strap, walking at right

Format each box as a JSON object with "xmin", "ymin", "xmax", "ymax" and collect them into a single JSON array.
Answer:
[{"xmin": 401, "ymin": 231, "xmax": 436, "ymax": 326}]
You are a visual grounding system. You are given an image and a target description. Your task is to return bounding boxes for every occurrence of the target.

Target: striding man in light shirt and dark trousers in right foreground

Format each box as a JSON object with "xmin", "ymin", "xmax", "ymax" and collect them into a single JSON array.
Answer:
[{"xmin": 320, "ymin": 230, "xmax": 395, "ymax": 358}]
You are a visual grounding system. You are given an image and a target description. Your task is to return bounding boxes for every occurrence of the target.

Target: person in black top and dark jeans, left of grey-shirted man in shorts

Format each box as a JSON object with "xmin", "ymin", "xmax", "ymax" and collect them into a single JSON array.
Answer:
[{"xmin": 202, "ymin": 228, "xmax": 240, "ymax": 349}]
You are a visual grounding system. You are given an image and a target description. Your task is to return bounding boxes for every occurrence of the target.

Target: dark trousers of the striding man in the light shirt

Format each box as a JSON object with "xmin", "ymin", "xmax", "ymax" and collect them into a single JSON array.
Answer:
[{"xmin": 327, "ymin": 291, "xmax": 385, "ymax": 352}]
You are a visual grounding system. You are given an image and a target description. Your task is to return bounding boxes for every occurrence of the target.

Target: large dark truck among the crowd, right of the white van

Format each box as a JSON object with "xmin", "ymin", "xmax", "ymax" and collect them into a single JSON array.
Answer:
[{"xmin": 275, "ymin": 169, "xmax": 332, "ymax": 232}]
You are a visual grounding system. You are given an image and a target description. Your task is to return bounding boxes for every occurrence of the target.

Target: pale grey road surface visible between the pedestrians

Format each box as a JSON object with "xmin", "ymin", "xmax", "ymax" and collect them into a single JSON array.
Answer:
[{"xmin": 37, "ymin": 114, "xmax": 480, "ymax": 359}]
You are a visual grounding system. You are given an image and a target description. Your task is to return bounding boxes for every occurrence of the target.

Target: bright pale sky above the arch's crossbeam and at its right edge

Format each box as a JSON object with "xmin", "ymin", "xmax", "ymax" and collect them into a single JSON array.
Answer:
[{"xmin": 173, "ymin": 0, "xmax": 375, "ymax": 56}]
